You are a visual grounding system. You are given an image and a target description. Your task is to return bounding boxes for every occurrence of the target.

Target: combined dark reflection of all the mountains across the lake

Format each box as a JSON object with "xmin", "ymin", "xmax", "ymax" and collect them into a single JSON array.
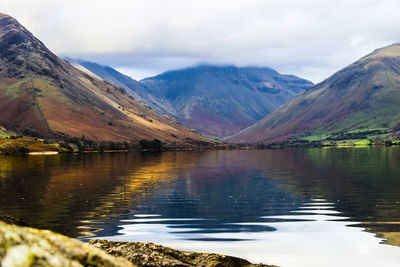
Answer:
[{"xmin": 0, "ymin": 148, "xmax": 400, "ymax": 248}]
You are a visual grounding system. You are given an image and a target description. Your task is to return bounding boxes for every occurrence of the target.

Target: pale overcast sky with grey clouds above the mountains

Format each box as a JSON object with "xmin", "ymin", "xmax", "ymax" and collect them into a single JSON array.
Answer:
[{"xmin": 0, "ymin": 0, "xmax": 400, "ymax": 83}]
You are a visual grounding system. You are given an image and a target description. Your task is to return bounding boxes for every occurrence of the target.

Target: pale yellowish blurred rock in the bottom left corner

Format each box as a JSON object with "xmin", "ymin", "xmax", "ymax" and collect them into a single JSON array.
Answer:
[{"xmin": 0, "ymin": 222, "xmax": 135, "ymax": 267}]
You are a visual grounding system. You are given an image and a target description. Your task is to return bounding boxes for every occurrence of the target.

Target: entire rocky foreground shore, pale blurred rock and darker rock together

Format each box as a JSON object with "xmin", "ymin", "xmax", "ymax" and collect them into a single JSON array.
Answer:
[{"xmin": 0, "ymin": 214, "xmax": 270, "ymax": 267}]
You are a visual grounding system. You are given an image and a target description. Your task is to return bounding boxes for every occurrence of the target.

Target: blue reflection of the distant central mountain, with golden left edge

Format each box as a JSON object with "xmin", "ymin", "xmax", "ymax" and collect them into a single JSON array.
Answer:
[{"xmin": 83, "ymin": 152, "xmax": 316, "ymax": 241}]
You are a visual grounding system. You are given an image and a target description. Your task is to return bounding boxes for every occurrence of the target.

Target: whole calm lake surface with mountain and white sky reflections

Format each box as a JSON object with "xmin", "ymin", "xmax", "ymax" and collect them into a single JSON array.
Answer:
[{"xmin": 0, "ymin": 150, "xmax": 400, "ymax": 266}]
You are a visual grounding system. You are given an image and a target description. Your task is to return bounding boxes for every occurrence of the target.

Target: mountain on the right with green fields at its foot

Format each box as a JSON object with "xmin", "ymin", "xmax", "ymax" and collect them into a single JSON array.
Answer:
[{"xmin": 227, "ymin": 44, "xmax": 400, "ymax": 143}]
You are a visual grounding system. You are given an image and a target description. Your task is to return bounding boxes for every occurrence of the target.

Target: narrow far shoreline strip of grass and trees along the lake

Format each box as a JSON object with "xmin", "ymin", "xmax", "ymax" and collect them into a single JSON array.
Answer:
[{"xmin": 0, "ymin": 137, "xmax": 400, "ymax": 155}]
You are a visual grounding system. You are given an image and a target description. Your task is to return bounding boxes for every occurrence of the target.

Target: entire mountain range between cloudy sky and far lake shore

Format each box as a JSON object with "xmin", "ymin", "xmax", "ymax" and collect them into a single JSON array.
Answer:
[{"xmin": 0, "ymin": 14, "xmax": 400, "ymax": 151}]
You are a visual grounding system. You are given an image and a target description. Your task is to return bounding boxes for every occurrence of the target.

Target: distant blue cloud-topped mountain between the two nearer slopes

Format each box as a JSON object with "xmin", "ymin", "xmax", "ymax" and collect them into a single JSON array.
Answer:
[{"xmin": 79, "ymin": 60, "xmax": 312, "ymax": 138}]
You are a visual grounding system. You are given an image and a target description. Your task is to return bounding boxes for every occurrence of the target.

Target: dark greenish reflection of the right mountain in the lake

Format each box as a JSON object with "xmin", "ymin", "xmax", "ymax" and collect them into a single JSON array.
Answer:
[{"xmin": 248, "ymin": 147, "xmax": 400, "ymax": 246}]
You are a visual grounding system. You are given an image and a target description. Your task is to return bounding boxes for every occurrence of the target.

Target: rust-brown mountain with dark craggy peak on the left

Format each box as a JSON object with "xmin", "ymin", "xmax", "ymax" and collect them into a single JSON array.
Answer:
[{"xmin": 0, "ymin": 14, "xmax": 209, "ymax": 146}]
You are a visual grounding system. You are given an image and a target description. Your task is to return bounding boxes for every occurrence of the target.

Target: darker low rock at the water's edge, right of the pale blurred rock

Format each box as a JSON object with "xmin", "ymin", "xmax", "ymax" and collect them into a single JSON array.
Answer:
[{"xmin": 89, "ymin": 240, "xmax": 276, "ymax": 267}]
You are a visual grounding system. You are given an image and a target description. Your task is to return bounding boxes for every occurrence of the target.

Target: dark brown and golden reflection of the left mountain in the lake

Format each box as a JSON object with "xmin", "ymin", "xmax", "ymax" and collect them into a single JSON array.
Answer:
[{"xmin": 0, "ymin": 154, "xmax": 183, "ymax": 236}]
